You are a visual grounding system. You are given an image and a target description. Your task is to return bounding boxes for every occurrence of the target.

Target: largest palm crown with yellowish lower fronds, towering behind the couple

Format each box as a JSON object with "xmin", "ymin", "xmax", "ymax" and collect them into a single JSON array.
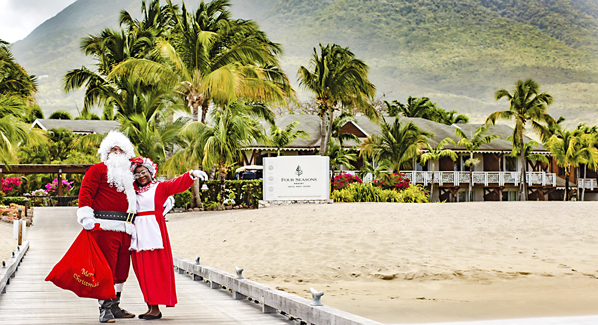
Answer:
[{"xmin": 113, "ymin": 0, "xmax": 293, "ymax": 123}]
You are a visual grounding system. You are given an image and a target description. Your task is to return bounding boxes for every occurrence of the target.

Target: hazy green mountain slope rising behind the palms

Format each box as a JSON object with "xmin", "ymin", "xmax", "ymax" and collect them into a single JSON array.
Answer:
[{"xmin": 13, "ymin": 0, "xmax": 598, "ymax": 124}]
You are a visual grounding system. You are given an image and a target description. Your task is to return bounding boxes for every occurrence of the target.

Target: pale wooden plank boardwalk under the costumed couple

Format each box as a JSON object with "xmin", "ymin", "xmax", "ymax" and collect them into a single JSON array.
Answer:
[{"xmin": 0, "ymin": 208, "xmax": 294, "ymax": 325}]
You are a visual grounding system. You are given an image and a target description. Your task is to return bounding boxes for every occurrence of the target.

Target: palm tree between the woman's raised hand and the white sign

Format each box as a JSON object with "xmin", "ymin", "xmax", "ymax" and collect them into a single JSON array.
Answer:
[{"xmin": 197, "ymin": 103, "xmax": 266, "ymax": 210}]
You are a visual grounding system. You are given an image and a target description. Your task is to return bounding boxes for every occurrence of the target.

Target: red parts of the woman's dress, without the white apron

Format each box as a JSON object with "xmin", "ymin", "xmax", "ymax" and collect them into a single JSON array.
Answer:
[{"xmin": 131, "ymin": 172, "xmax": 193, "ymax": 307}]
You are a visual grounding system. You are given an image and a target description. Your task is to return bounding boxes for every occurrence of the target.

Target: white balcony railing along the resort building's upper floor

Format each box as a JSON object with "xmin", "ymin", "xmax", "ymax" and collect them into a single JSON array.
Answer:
[{"xmin": 401, "ymin": 170, "xmax": 556, "ymax": 186}]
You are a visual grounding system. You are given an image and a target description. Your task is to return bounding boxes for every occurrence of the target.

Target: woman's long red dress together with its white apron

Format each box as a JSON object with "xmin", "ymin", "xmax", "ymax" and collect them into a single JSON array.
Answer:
[{"xmin": 131, "ymin": 172, "xmax": 193, "ymax": 307}]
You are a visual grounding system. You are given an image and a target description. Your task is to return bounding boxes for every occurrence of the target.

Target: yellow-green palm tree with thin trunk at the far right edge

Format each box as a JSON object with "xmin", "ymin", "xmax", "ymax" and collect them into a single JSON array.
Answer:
[{"xmin": 546, "ymin": 128, "xmax": 598, "ymax": 201}]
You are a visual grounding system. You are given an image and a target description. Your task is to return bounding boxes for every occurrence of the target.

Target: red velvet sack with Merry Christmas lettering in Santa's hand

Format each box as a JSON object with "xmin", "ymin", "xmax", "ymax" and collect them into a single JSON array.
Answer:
[{"xmin": 46, "ymin": 229, "xmax": 116, "ymax": 300}]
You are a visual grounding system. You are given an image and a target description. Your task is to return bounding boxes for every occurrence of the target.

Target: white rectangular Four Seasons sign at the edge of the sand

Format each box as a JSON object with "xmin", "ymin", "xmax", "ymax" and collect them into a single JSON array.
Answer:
[{"xmin": 264, "ymin": 156, "xmax": 330, "ymax": 201}]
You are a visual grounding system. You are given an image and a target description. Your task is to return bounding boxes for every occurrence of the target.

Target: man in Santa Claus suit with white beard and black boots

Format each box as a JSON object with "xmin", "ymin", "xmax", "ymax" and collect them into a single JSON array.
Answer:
[{"xmin": 77, "ymin": 131, "xmax": 136, "ymax": 323}]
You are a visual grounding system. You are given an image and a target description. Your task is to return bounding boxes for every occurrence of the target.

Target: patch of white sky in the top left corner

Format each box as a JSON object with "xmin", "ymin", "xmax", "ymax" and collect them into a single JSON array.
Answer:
[{"xmin": 0, "ymin": 0, "xmax": 76, "ymax": 43}]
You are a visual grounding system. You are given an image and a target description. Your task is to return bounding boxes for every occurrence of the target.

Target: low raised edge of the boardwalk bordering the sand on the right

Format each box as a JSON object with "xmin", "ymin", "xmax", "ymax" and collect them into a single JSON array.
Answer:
[{"xmin": 174, "ymin": 256, "xmax": 382, "ymax": 325}]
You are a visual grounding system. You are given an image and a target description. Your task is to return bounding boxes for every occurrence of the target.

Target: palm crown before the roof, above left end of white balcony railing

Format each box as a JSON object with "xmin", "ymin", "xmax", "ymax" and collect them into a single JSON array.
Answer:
[{"xmin": 360, "ymin": 118, "xmax": 432, "ymax": 173}]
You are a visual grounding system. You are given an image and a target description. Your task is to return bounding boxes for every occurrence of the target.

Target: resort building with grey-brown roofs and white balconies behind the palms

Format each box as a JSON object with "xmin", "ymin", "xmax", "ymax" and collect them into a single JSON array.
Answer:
[{"xmin": 243, "ymin": 114, "xmax": 598, "ymax": 202}]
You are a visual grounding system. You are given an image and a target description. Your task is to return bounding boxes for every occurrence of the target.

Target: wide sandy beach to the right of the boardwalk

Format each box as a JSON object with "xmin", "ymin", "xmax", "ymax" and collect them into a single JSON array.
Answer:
[{"xmin": 167, "ymin": 202, "xmax": 598, "ymax": 323}]
